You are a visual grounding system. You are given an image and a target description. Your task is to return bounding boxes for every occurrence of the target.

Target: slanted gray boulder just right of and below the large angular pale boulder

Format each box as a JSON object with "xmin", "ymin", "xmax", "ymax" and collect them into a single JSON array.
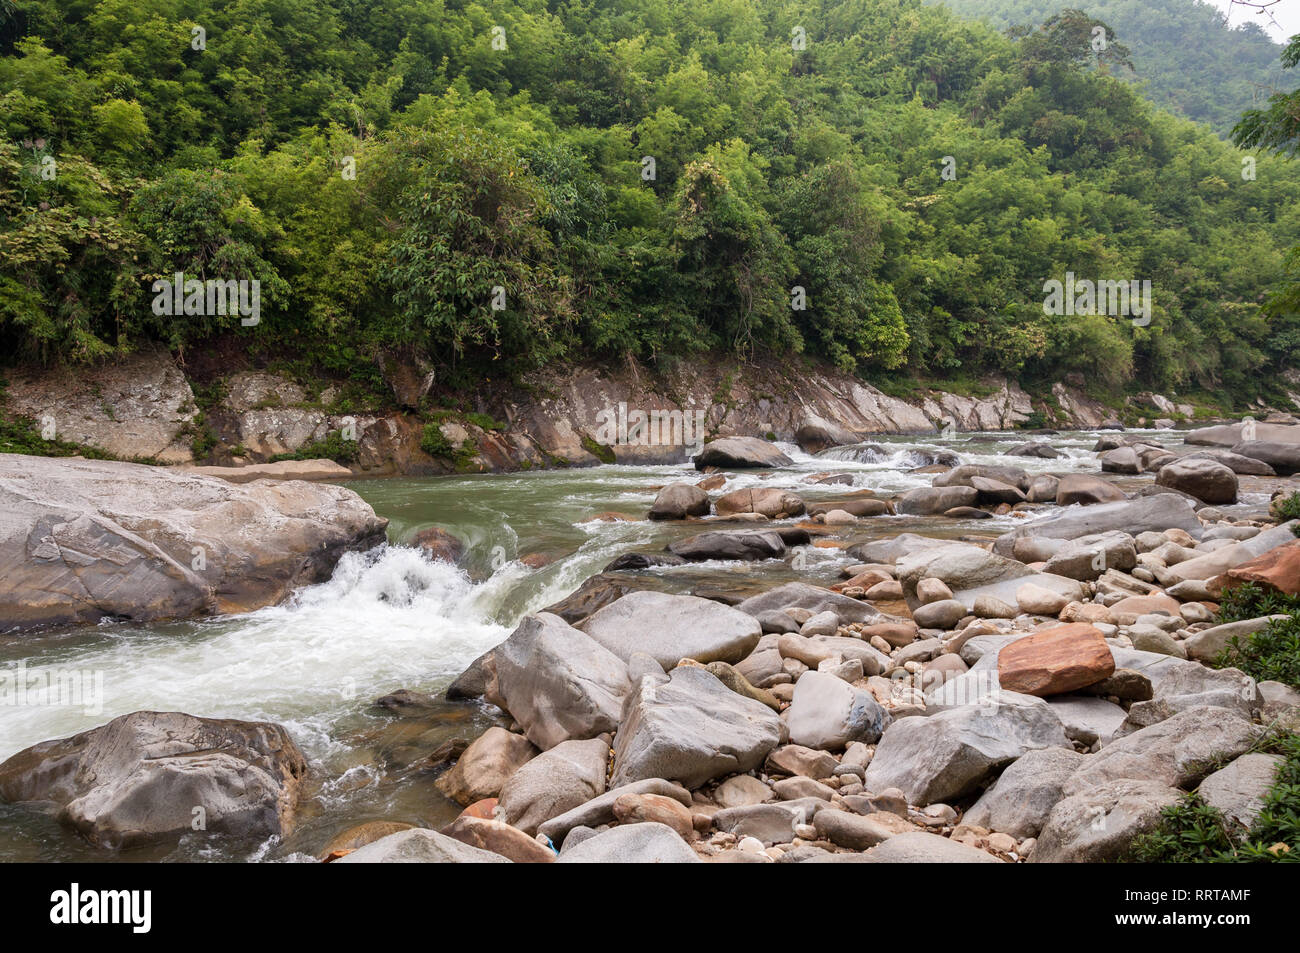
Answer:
[{"xmin": 962, "ymin": 748, "xmax": 1084, "ymax": 839}]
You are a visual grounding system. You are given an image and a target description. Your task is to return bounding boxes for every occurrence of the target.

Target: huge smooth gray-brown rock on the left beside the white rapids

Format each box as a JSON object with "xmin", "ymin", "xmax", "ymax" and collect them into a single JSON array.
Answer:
[{"xmin": 0, "ymin": 454, "xmax": 387, "ymax": 629}]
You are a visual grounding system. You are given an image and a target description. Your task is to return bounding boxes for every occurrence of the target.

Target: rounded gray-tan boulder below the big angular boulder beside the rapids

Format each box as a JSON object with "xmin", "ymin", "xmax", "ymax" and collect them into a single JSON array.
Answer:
[{"xmin": 499, "ymin": 738, "xmax": 610, "ymax": 836}]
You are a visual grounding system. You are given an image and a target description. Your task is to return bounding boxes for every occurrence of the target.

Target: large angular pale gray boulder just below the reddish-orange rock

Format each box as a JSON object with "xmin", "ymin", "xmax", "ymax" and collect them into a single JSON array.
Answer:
[{"xmin": 866, "ymin": 692, "xmax": 1070, "ymax": 805}]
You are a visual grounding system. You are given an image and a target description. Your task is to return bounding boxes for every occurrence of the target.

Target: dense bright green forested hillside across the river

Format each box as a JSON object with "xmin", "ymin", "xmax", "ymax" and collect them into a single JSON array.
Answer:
[{"xmin": 0, "ymin": 0, "xmax": 1300, "ymax": 399}]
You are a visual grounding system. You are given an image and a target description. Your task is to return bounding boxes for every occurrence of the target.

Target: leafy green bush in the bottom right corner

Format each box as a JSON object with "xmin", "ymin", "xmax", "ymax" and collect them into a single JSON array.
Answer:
[{"xmin": 1125, "ymin": 733, "xmax": 1300, "ymax": 863}]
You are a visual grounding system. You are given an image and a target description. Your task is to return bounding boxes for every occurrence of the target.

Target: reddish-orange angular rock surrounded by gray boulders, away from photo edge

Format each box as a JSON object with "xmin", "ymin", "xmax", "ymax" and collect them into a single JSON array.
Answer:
[{"xmin": 997, "ymin": 623, "xmax": 1115, "ymax": 697}]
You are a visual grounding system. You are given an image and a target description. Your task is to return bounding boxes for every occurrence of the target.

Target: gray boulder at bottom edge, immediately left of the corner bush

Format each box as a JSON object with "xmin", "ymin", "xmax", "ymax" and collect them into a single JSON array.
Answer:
[{"xmin": 1030, "ymin": 780, "xmax": 1182, "ymax": 863}]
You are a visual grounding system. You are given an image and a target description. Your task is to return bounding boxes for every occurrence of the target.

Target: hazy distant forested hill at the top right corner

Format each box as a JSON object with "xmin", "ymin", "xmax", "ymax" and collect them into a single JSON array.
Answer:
[{"xmin": 933, "ymin": 0, "xmax": 1283, "ymax": 135}]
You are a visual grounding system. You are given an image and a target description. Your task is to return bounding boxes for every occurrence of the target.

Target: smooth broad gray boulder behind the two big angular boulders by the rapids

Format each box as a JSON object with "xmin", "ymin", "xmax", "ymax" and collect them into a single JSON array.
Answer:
[{"xmin": 579, "ymin": 592, "xmax": 763, "ymax": 671}]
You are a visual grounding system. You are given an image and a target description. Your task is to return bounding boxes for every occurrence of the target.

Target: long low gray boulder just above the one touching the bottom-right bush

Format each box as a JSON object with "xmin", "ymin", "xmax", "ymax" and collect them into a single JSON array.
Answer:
[{"xmin": 1066, "ymin": 706, "xmax": 1262, "ymax": 794}]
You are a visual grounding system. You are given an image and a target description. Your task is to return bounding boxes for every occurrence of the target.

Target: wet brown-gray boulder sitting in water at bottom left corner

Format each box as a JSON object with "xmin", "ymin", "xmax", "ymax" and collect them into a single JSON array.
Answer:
[{"xmin": 0, "ymin": 711, "xmax": 307, "ymax": 848}]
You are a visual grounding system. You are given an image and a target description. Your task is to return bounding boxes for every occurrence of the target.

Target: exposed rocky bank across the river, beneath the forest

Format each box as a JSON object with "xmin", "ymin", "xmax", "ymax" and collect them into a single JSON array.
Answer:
[{"xmin": 3, "ymin": 351, "xmax": 1268, "ymax": 476}]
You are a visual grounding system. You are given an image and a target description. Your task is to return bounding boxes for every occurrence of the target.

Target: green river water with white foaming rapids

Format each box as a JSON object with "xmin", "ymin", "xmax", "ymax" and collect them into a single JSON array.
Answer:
[{"xmin": 0, "ymin": 432, "xmax": 1237, "ymax": 861}]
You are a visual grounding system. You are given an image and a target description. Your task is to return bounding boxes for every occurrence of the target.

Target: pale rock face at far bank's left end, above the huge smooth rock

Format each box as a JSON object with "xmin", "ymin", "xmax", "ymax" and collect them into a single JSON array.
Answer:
[{"xmin": 4, "ymin": 351, "xmax": 198, "ymax": 463}]
